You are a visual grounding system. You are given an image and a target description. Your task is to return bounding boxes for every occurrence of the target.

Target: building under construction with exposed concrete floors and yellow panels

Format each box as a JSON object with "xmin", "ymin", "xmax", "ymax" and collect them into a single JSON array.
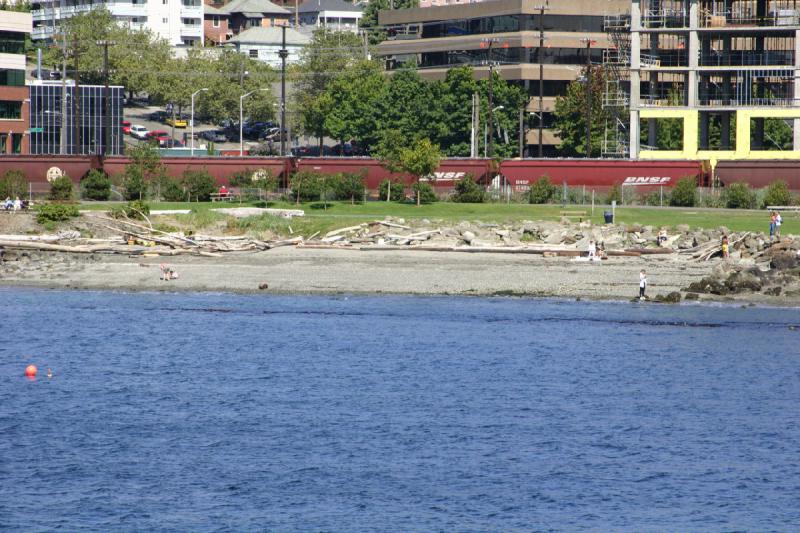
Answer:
[{"xmin": 628, "ymin": 0, "xmax": 800, "ymax": 160}]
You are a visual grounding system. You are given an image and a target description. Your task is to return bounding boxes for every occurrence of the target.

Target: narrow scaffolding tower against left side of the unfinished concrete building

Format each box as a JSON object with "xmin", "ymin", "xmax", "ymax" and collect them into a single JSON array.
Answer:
[{"xmin": 602, "ymin": 15, "xmax": 631, "ymax": 158}]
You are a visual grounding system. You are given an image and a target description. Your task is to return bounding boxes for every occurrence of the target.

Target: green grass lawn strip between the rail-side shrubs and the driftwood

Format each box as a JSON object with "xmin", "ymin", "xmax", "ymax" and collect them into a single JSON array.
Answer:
[{"xmin": 81, "ymin": 201, "xmax": 800, "ymax": 236}]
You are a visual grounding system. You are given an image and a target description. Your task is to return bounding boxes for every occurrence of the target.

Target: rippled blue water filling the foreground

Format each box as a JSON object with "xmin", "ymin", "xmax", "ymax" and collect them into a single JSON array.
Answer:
[{"xmin": 0, "ymin": 289, "xmax": 800, "ymax": 531}]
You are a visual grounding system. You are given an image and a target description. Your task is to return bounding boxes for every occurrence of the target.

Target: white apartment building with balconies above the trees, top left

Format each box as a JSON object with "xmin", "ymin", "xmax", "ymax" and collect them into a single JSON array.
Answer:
[{"xmin": 31, "ymin": 0, "xmax": 203, "ymax": 46}]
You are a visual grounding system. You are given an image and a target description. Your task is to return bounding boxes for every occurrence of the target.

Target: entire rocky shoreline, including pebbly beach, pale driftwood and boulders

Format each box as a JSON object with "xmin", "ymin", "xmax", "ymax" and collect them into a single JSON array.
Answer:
[{"xmin": 0, "ymin": 211, "xmax": 800, "ymax": 306}]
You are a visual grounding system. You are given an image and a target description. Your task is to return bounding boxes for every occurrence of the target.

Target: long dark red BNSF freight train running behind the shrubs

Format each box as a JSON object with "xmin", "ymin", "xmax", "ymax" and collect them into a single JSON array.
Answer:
[{"xmin": 0, "ymin": 155, "xmax": 708, "ymax": 191}]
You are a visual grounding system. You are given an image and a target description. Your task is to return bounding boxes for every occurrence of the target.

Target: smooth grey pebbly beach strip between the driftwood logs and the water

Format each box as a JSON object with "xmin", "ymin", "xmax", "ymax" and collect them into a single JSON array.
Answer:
[{"xmin": 0, "ymin": 247, "xmax": 800, "ymax": 305}]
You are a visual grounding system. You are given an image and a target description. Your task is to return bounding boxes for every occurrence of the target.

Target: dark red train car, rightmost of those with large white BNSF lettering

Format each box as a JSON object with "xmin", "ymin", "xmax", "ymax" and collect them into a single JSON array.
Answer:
[{"xmin": 500, "ymin": 159, "xmax": 706, "ymax": 192}]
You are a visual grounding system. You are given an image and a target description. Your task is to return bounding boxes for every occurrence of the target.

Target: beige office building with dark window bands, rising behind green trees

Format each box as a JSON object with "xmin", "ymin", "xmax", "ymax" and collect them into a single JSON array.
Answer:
[{"xmin": 377, "ymin": 0, "xmax": 630, "ymax": 156}]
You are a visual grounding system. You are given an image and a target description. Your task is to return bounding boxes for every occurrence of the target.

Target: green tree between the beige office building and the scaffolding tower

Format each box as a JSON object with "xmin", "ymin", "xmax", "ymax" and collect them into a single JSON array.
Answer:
[{"xmin": 554, "ymin": 67, "xmax": 610, "ymax": 157}]
